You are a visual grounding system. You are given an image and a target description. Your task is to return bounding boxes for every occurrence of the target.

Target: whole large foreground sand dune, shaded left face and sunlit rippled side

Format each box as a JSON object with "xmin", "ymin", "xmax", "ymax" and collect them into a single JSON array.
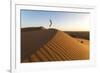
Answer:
[{"xmin": 21, "ymin": 29, "xmax": 89, "ymax": 63}]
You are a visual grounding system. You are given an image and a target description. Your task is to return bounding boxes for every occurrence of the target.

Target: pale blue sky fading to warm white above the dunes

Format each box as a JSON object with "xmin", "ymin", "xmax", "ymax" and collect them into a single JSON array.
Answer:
[{"xmin": 21, "ymin": 10, "xmax": 90, "ymax": 31}]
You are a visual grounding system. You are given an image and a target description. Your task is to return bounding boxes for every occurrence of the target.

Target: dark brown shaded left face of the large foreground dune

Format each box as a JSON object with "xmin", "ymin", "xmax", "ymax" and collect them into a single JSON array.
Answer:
[{"xmin": 21, "ymin": 28, "xmax": 57, "ymax": 61}]
